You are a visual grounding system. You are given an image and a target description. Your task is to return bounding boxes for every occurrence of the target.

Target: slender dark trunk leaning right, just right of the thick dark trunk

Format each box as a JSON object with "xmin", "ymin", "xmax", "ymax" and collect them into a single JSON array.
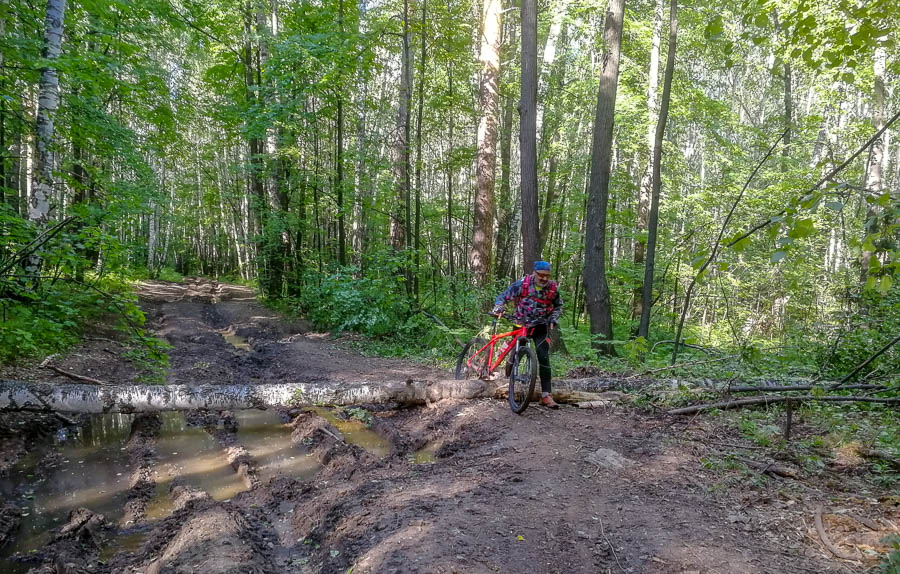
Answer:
[{"xmin": 638, "ymin": 0, "xmax": 678, "ymax": 339}]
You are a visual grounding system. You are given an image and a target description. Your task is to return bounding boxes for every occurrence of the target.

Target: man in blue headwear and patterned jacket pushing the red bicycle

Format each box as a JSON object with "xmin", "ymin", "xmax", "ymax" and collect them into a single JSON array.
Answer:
[{"xmin": 492, "ymin": 261, "xmax": 562, "ymax": 409}]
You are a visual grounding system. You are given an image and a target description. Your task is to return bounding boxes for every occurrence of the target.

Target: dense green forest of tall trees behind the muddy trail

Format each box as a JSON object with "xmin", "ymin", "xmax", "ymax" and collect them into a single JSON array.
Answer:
[{"xmin": 0, "ymin": 0, "xmax": 900, "ymax": 382}]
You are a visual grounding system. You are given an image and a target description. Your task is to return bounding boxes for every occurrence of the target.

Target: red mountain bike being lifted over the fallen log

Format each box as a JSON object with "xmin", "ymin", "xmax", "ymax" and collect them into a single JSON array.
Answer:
[{"xmin": 456, "ymin": 315, "xmax": 538, "ymax": 414}]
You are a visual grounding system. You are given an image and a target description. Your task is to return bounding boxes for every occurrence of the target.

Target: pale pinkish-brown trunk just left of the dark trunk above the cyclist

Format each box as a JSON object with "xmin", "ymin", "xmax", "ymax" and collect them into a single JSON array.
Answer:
[{"xmin": 469, "ymin": 0, "xmax": 501, "ymax": 285}]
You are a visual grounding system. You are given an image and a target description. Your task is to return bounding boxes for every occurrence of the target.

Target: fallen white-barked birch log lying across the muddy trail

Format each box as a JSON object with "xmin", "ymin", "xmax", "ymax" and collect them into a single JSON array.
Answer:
[{"xmin": 0, "ymin": 379, "xmax": 614, "ymax": 413}]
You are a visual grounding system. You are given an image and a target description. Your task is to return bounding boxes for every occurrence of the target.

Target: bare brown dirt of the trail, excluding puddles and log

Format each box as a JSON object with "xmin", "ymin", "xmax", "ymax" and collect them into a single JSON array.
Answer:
[{"xmin": 0, "ymin": 281, "xmax": 898, "ymax": 574}]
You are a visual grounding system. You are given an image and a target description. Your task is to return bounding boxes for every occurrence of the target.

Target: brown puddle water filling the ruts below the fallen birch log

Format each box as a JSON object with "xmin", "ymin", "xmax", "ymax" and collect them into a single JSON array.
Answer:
[{"xmin": 0, "ymin": 410, "xmax": 320, "ymax": 574}]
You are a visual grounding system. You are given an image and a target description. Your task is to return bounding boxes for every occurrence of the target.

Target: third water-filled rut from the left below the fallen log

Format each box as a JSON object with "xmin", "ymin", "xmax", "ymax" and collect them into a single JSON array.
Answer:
[{"xmin": 234, "ymin": 410, "xmax": 321, "ymax": 482}]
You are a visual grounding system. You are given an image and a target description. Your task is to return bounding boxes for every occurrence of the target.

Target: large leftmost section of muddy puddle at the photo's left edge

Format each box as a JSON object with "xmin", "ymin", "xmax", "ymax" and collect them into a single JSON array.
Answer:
[{"xmin": 0, "ymin": 414, "xmax": 134, "ymax": 574}]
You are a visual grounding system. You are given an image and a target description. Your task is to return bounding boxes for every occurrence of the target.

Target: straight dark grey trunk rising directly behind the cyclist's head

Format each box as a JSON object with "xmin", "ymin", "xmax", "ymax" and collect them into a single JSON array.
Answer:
[{"xmin": 519, "ymin": 0, "xmax": 541, "ymax": 270}]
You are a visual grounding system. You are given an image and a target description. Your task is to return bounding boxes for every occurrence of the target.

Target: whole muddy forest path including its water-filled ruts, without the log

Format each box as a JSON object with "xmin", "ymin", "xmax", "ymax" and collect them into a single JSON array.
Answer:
[{"xmin": 0, "ymin": 280, "xmax": 900, "ymax": 574}]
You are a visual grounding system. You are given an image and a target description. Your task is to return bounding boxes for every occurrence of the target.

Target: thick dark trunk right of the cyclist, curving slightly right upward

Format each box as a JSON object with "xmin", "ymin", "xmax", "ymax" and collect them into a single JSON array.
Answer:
[{"xmin": 584, "ymin": 0, "xmax": 625, "ymax": 355}]
